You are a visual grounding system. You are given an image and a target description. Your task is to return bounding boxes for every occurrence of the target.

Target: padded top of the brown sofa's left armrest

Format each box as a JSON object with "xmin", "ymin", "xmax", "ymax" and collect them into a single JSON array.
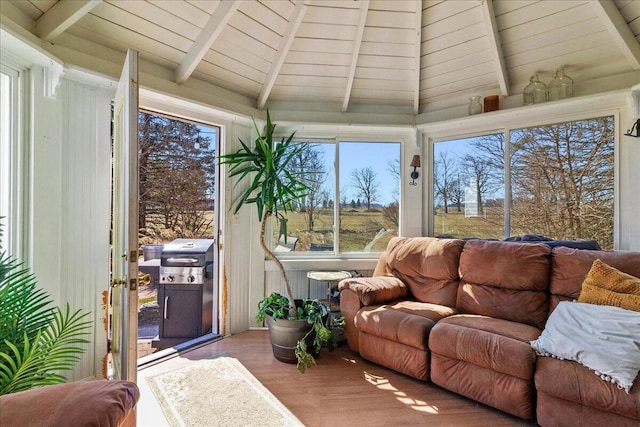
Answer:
[{"xmin": 338, "ymin": 276, "xmax": 409, "ymax": 306}]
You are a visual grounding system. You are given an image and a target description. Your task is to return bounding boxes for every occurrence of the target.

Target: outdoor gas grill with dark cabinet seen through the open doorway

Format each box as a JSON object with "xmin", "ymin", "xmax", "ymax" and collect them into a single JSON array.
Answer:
[{"xmin": 153, "ymin": 239, "xmax": 215, "ymax": 348}]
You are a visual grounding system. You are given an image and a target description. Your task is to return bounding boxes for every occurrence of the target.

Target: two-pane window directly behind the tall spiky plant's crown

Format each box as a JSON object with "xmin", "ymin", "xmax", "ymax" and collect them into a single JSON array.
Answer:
[{"xmin": 273, "ymin": 141, "xmax": 400, "ymax": 256}]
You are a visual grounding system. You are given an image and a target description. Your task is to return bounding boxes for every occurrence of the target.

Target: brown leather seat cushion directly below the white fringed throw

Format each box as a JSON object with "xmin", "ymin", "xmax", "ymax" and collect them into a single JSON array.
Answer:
[{"xmin": 535, "ymin": 357, "xmax": 640, "ymax": 426}]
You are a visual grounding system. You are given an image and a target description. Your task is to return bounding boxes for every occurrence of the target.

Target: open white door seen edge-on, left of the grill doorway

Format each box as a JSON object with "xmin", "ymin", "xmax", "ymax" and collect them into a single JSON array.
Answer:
[{"xmin": 111, "ymin": 49, "xmax": 138, "ymax": 381}]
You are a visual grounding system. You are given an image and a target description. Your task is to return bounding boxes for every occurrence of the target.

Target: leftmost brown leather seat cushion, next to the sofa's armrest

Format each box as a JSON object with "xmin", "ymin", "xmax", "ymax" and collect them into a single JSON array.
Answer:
[{"xmin": 355, "ymin": 301, "xmax": 455, "ymax": 350}]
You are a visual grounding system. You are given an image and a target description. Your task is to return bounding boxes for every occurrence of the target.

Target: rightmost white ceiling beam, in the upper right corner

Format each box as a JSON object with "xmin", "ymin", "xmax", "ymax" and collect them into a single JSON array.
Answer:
[{"xmin": 590, "ymin": 0, "xmax": 640, "ymax": 70}]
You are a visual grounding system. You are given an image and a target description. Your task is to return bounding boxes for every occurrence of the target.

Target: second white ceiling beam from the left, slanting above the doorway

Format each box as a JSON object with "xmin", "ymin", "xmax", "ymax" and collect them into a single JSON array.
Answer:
[{"xmin": 176, "ymin": 0, "xmax": 240, "ymax": 83}]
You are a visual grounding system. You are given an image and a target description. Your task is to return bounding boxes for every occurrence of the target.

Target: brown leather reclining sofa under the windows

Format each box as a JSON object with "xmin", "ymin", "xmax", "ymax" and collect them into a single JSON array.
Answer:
[{"xmin": 339, "ymin": 237, "xmax": 640, "ymax": 426}]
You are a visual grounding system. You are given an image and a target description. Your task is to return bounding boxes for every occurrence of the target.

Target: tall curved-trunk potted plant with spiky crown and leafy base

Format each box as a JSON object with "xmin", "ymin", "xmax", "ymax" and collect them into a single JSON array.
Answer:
[{"xmin": 219, "ymin": 109, "xmax": 335, "ymax": 372}]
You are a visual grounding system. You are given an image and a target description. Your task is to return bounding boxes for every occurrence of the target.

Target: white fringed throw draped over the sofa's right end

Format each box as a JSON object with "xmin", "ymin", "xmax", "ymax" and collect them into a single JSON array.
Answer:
[{"xmin": 531, "ymin": 301, "xmax": 640, "ymax": 392}]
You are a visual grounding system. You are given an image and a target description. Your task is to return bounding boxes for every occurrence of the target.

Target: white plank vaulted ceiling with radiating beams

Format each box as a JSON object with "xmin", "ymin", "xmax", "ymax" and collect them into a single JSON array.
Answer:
[{"xmin": 0, "ymin": 0, "xmax": 640, "ymax": 122}]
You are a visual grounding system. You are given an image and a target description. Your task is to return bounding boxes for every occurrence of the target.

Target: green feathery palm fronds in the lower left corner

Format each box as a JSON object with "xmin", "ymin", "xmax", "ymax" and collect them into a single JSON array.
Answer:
[{"xmin": 0, "ymin": 222, "xmax": 92, "ymax": 396}]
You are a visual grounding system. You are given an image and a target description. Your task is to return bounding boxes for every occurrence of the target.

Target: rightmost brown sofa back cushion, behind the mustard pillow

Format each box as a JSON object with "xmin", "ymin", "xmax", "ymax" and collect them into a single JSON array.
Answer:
[{"xmin": 549, "ymin": 247, "xmax": 640, "ymax": 314}]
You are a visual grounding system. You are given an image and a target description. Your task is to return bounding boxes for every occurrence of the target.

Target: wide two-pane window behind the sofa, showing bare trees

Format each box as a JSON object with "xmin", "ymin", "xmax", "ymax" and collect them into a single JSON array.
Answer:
[{"xmin": 433, "ymin": 116, "xmax": 614, "ymax": 249}]
